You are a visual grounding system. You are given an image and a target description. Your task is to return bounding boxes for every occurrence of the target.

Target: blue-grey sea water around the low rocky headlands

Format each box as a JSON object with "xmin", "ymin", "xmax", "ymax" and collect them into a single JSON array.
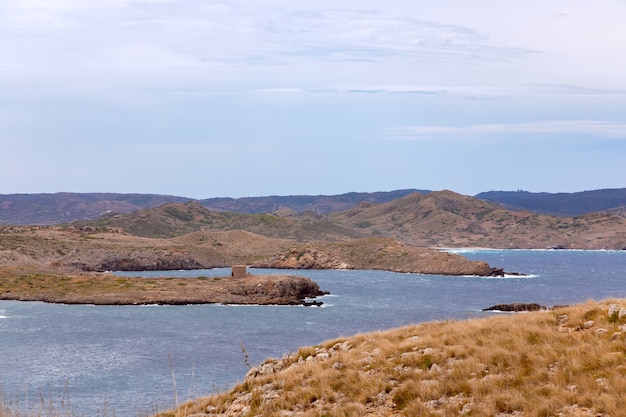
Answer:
[{"xmin": 0, "ymin": 249, "xmax": 626, "ymax": 417}]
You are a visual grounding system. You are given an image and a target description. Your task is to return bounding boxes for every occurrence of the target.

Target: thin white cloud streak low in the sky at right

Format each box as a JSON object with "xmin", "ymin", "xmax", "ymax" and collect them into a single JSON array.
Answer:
[{"xmin": 383, "ymin": 120, "xmax": 626, "ymax": 140}]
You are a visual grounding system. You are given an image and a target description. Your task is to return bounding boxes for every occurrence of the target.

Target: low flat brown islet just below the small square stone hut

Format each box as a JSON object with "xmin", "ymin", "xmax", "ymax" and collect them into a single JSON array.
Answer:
[{"xmin": 0, "ymin": 268, "xmax": 327, "ymax": 305}]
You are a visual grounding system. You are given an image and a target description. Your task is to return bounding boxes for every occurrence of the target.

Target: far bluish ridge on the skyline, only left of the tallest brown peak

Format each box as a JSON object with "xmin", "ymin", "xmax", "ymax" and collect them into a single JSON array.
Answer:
[{"xmin": 0, "ymin": 190, "xmax": 427, "ymax": 225}]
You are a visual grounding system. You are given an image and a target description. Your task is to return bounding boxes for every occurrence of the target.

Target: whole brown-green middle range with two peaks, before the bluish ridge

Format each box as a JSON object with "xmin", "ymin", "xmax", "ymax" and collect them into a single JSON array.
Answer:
[{"xmin": 69, "ymin": 191, "xmax": 626, "ymax": 249}]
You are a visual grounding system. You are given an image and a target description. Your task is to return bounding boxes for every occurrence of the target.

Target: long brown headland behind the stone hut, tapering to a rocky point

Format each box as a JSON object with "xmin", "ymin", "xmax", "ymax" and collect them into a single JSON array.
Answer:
[{"xmin": 0, "ymin": 226, "xmax": 503, "ymax": 276}]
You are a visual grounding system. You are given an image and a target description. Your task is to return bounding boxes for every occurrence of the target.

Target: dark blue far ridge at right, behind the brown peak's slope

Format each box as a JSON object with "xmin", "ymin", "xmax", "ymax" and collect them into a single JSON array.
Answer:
[{"xmin": 476, "ymin": 188, "xmax": 626, "ymax": 216}]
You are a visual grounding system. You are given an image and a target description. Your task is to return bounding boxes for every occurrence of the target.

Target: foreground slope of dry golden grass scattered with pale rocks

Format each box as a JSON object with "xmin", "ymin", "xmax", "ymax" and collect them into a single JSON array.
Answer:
[{"xmin": 159, "ymin": 300, "xmax": 626, "ymax": 417}]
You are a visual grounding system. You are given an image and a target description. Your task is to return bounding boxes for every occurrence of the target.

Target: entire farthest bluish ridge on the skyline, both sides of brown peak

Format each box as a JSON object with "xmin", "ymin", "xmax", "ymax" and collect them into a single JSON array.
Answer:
[{"xmin": 0, "ymin": 188, "xmax": 626, "ymax": 225}]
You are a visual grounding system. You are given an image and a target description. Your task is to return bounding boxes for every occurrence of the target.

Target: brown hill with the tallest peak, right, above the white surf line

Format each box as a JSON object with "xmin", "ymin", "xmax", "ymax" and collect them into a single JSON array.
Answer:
[{"xmin": 328, "ymin": 191, "xmax": 626, "ymax": 249}]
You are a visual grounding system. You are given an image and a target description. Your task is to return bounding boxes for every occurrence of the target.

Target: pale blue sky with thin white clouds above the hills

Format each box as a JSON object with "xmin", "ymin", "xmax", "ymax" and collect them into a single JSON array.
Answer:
[{"xmin": 0, "ymin": 0, "xmax": 626, "ymax": 198}]
